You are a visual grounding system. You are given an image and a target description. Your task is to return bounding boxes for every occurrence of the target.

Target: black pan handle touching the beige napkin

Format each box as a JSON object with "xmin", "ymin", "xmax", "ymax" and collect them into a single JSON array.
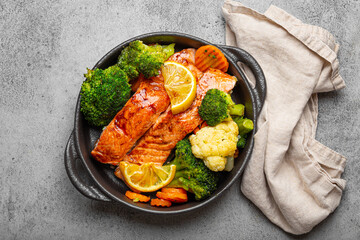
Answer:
[{"xmin": 221, "ymin": 45, "xmax": 266, "ymax": 113}]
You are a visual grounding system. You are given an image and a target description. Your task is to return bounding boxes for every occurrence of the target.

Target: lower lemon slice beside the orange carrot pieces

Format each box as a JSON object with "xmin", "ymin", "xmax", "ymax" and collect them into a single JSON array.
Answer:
[{"xmin": 119, "ymin": 161, "xmax": 176, "ymax": 192}]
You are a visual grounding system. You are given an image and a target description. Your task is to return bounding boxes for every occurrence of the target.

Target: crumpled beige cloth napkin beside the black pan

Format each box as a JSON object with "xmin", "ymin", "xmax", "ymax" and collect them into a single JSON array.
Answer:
[{"xmin": 222, "ymin": 0, "xmax": 346, "ymax": 234}]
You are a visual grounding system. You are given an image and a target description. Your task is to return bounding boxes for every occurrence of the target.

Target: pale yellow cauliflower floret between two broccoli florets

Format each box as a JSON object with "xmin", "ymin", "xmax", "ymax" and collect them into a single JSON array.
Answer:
[{"xmin": 189, "ymin": 120, "xmax": 239, "ymax": 172}]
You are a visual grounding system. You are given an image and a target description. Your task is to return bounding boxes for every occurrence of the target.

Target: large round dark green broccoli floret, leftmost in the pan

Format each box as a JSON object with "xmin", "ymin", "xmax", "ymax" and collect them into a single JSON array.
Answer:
[{"xmin": 80, "ymin": 65, "xmax": 131, "ymax": 127}]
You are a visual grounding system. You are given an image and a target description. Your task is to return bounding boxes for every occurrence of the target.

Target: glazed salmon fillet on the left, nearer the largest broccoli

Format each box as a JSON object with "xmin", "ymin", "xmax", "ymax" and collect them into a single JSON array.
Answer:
[{"xmin": 91, "ymin": 49, "xmax": 197, "ymax": 165}]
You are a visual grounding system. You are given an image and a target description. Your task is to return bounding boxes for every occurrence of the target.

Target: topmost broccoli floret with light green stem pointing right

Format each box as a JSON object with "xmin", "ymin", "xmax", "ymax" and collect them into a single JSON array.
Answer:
[{"xmin": 118, "ymin": 40, "xmax": 175, "ymax": 80}]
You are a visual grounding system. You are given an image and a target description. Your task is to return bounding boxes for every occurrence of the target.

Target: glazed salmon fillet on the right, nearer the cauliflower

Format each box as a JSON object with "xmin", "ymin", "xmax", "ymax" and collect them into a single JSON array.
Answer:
[{"xmin": 124, "ymin": 68, "xmax": 236, "ymax": 164}]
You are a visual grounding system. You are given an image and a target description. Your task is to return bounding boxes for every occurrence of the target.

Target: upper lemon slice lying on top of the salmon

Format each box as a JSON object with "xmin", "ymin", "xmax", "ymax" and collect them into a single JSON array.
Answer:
[{"xmin": 161, "ymin": 61, "xmax": 196, "ymax": 115}]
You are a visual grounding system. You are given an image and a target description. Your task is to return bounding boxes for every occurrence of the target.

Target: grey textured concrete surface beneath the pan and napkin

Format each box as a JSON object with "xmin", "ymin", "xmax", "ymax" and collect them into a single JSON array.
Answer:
[{"xmin": 0, "ymin": 0, "xmax": 360, "ymax": 239}]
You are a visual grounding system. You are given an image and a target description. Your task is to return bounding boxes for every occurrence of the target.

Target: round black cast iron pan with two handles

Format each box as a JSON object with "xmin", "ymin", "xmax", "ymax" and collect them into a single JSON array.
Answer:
[{"xmin": 65, "ymin": 32, "xmax": 266, "ymax": 214}]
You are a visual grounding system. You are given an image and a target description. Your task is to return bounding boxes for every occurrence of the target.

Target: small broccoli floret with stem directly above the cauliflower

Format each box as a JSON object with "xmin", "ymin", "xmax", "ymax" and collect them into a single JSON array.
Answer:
[{"xmin": 199, "ymin": 88, "xmax": 244, "ymax": 126}]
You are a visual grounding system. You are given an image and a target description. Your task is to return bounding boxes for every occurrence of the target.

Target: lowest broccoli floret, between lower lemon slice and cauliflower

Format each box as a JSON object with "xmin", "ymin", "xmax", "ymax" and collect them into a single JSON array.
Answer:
[{"xmin": 167, "ymin": 139, "xmax": 219, "ymax": 200}]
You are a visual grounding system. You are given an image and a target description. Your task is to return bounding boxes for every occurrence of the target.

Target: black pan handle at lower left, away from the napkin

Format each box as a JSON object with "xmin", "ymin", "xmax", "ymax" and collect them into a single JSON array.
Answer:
[{"xmin": 64, "ymin": 132, "xmax": 112, "ymax": 202}]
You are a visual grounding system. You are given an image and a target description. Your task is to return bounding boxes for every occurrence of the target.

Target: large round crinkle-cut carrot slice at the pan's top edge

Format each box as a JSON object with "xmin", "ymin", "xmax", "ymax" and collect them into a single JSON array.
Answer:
[{"xmin": 195, "ymin": 45, "xmax": 229, "ymax": 72}]
